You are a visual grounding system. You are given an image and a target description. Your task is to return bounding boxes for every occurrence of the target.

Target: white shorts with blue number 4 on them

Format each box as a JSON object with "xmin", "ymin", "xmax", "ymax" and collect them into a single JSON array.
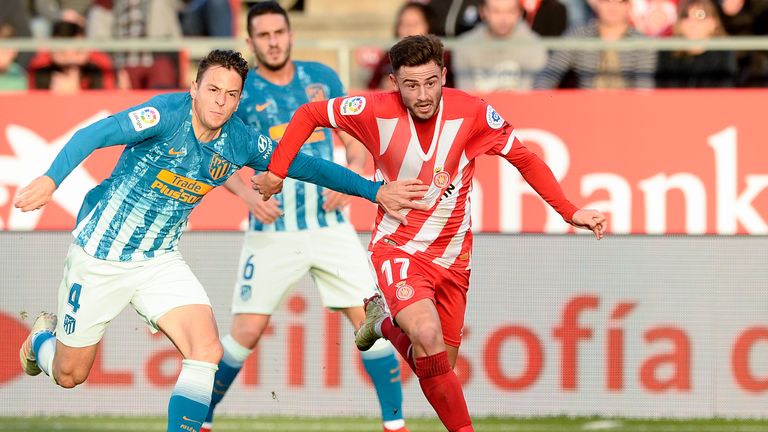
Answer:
[{"xmin": 56, "ymin": 244, "xmax": 211, "ymax": 347}]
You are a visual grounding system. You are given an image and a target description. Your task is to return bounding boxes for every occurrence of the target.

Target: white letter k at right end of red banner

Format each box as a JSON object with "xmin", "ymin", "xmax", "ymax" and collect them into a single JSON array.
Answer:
[{"xmin": 707, "ymin": 127, "xmax": 768, "ymax": 234}]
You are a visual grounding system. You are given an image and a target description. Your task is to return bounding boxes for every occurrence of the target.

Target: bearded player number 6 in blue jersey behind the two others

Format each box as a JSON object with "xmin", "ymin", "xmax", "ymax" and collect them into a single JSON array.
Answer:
[{"xmin": 202, "ymin": 1, "xmax": 407, "ymax": 432}]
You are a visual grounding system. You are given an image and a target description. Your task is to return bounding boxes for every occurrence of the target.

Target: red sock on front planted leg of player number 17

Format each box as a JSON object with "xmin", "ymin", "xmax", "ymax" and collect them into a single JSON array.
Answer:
[{"xmin": 416, "ymin": 351, "xmax": 474, "ymax": 432}]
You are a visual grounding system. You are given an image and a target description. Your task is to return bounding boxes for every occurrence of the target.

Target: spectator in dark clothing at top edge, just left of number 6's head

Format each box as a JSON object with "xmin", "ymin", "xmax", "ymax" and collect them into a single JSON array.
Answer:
[{"xmin": 179, "ymin": 0, "xmax": 235, "ymax": 37}]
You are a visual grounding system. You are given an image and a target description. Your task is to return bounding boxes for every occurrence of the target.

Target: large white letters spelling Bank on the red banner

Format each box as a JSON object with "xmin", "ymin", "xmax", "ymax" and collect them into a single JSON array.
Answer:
[{"xmin": 496, "ymin": 127, "xmax": 768, "ymax": 234}]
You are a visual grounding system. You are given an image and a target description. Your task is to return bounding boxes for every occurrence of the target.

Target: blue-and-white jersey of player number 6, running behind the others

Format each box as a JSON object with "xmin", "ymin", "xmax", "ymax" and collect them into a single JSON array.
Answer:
[{"xmin": 237, "ymin": 61, "xmax": 345, "ymax": 231}]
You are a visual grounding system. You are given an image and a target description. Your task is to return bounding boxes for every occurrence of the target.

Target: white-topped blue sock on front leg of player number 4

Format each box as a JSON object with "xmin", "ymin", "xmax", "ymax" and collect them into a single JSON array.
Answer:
[{"xmin": 168, "ymin": 360, "xmax": 216, "ymax": 432}]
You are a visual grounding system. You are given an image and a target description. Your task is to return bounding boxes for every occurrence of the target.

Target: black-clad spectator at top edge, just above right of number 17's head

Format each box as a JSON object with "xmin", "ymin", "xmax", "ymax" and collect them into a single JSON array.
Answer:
[{"xmin": 422, "ymin": 0, "xmax": 482, "ymax": 37}]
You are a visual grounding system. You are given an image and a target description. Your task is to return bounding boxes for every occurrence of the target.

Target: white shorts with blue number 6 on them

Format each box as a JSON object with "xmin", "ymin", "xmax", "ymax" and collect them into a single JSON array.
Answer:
[{"xmin": 232, "ymin": 224, "xmax": 375, "ymax": 315}]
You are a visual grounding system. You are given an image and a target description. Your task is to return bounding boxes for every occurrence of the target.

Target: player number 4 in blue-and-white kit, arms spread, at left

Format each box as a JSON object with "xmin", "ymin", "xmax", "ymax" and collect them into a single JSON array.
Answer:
[{"xmin": 15, "ymin": 50, "xmax": 424, "ymax": 432}]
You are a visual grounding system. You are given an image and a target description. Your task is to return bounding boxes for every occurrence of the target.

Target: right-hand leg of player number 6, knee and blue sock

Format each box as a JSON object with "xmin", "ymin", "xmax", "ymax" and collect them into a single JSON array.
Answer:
[{"xmin": 341, "ymin": 306, "xmax": 408, "ymax": 432}]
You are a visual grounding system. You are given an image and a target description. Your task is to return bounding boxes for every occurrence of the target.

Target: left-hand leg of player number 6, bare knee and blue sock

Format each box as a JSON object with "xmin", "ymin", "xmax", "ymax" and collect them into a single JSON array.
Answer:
[{"xmin": 200, "ymin": 313, "xmax": 271, "ymax": 432}]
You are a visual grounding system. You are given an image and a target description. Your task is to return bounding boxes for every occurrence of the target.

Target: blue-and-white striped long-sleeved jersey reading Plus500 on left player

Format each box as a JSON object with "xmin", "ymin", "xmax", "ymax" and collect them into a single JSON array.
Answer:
[{"xmin": 46, "ymin": 93, "xmax": 379, "ymax": 261}]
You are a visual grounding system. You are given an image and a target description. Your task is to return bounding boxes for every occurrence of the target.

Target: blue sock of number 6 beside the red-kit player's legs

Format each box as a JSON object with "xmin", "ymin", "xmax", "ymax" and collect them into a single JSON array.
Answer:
[{"xmin": 360, "ymin": 342, "xmax": 403, "ymax": 422}]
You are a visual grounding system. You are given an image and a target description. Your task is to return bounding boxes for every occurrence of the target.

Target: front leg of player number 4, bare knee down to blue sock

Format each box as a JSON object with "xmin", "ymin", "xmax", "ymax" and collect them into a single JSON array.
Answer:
[{"xmin": 157, "ymin": 305, "xmax": 222, "ymax": 432}]
